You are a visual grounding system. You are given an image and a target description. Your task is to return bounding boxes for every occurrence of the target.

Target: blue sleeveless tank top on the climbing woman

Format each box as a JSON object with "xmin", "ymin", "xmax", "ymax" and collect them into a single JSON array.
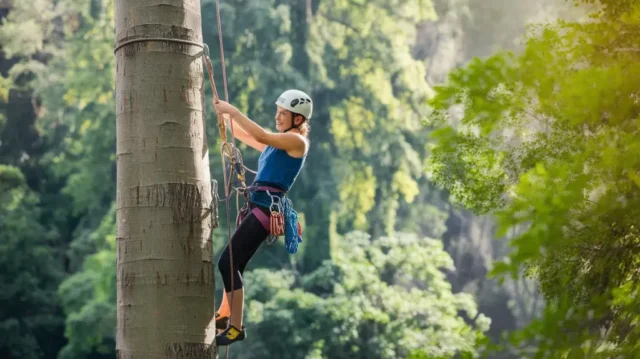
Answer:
[{"xmin": 254, "ymin": 146, "xmax": 307, "ymax": 191}]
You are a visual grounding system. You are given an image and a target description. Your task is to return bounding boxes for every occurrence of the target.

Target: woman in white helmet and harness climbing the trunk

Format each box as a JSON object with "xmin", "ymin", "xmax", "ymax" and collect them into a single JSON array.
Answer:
[{"xmin": 214, "ymin": 90, "xmax": 313, "ymax": 345}]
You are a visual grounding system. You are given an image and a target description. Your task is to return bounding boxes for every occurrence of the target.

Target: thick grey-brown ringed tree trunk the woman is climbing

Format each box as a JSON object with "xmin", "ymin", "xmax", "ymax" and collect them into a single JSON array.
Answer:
[{"xmin": 115, "ymin": 0, "xmax": 217, "ymax": 359}]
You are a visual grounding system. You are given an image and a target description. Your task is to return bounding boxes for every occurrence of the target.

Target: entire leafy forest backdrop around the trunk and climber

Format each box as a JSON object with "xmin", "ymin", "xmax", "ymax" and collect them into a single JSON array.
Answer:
[{"xmin": 0, "ymin": 0, "xmax": 640, "ymax": 359}]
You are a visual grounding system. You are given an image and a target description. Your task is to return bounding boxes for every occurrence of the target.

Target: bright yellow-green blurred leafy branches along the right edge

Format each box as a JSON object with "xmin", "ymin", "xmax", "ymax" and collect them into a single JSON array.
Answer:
[{"xmin": 428, "ymin": 2, "xmax": 640, "ymax": 358}]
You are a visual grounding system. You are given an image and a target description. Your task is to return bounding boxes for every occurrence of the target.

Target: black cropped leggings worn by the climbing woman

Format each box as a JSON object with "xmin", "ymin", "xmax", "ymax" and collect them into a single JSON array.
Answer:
[{"xmin": 218, "ymin": 207, "xmax": 269, "ymax": 292}]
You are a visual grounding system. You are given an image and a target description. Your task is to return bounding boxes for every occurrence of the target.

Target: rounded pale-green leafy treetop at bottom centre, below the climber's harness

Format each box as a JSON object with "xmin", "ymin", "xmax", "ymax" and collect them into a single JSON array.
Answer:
[{"xmin": 232, "ymin": 232, "xmax": 489, "ymax": 359}]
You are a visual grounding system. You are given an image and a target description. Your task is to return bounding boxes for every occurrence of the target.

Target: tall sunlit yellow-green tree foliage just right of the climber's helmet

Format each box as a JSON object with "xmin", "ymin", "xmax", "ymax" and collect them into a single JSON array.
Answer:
[{"xmin": 308, "ymin": 1, "xmax": 435, "ymax": 239}]
